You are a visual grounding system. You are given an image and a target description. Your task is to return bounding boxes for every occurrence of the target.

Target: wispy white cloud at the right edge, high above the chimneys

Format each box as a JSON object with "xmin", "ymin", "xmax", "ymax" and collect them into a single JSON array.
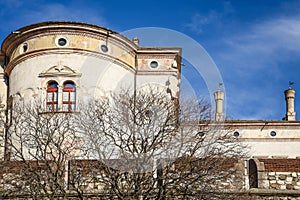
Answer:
[{"xmin": 227, "ymin": 19, "xmax": 300, "ymax": 56}]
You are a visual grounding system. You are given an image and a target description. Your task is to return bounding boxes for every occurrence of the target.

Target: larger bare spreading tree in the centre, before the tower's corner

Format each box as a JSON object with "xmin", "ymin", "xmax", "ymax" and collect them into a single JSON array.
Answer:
[{"xmin": 74, "ymin": 87, "xmax": 243, "ymax": 199}]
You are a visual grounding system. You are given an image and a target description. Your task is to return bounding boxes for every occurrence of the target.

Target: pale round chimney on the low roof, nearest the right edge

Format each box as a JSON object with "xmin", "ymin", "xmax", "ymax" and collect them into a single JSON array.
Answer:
[{"xmin": 284, "ymin": 87, "xmax": 296, "ymax": 121}]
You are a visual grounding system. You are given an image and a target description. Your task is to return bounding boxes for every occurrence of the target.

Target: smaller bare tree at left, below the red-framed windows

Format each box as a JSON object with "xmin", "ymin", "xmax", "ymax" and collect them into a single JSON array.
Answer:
[{"xmin": 1, "ymin": 103, "xmax": 80, "ymax": 199}]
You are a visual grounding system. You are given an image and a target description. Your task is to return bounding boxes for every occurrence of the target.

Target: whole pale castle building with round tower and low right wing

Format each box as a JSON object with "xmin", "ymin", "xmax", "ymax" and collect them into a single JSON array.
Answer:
[{"xmin": 0, "ymin": 21, "xmax": 300, "ymax": 196}]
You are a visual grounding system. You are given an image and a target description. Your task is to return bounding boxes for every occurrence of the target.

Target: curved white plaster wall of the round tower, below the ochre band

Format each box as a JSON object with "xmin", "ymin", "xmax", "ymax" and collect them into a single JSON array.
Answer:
[{"xmin": 10, "ymin": 54, "xmax": 133, "ymax": 103}]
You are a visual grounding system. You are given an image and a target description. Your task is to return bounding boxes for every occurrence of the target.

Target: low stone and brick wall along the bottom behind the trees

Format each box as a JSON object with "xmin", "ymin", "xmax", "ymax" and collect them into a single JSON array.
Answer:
[{"xmin": 0, "ymin": 159, "xmax": 300, "ymax": 200}]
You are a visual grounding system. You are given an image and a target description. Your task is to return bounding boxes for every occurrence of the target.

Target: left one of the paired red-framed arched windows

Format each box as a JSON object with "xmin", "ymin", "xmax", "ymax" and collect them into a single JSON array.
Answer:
[{"xmin": 47, "ymin": 81, "xmax": 58, "ymax": 112}]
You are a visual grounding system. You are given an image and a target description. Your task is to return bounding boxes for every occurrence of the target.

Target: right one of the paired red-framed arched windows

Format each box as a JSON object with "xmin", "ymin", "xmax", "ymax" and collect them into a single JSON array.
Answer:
[{"xmin": 63, "ymin": 81, "xmax": 76, "ymax": 112}]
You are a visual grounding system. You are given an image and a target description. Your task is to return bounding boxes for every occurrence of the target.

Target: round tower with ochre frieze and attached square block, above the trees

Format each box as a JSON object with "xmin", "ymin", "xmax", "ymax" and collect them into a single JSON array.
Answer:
[{"xmin": 1, "ymin": 21, "xmax": 181, "ymax": 111}]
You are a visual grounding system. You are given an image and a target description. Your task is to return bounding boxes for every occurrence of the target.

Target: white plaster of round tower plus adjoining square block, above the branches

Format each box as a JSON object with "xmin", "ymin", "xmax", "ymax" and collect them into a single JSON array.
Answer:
[{"xmin": 10, "ymin": 54, "xmax": 179, "ymax": 104}]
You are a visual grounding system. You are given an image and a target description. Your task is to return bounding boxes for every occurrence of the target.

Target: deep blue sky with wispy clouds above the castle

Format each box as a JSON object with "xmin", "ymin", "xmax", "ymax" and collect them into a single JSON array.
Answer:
[{"xmin": 0, "ymin": 0, "xmax": 300, "ymax": 120}]
